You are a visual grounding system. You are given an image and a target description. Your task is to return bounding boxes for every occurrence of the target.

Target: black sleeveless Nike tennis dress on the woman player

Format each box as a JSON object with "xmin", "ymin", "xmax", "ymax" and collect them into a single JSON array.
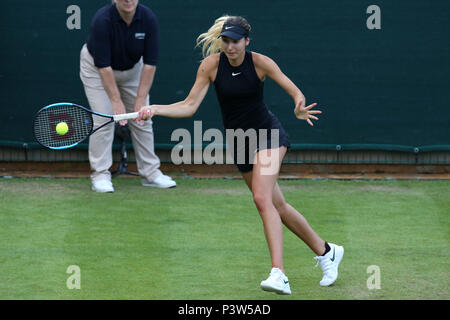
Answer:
[{"xmin": 214, "ymin": 51, "xmax": 290, "ymax": 172}]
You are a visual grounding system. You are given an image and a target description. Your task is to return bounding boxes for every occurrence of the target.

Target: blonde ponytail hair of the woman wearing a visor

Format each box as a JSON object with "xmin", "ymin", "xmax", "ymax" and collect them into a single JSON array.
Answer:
[{"xmin": 195, "ymin": 15, "xmax": 251, "ymax": 58}]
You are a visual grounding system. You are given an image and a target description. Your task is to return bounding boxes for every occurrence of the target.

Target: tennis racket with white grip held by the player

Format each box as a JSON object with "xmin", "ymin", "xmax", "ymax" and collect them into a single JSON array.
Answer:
[{"xmin": 33, "ymin": 103, "xmax": 139, "ymax": 150}]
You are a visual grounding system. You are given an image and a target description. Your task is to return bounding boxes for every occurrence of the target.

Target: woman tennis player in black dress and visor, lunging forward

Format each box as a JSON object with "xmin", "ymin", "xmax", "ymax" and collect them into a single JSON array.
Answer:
[{"xmin": 138, "ymin": 16, "xmax": 344, "ymax": 294}]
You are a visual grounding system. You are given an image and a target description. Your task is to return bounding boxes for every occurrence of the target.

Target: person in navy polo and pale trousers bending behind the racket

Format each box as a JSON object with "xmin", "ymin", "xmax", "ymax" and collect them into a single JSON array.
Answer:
[{"xmin": 80, "ymin": 0, "xmax": 176, "ymax": 192}]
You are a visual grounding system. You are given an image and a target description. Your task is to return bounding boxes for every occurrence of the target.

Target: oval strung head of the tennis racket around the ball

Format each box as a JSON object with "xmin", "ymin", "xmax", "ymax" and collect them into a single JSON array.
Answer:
[{"xmin": 34, "ymin": 105, "xmax": 93, "ymax": 149}]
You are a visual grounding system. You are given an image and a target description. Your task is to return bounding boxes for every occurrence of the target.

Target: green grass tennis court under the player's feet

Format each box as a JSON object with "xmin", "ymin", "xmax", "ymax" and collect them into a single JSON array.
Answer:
[{"xmin": 0, "ymin": 177, "xmax": 450, "ymax": 300}]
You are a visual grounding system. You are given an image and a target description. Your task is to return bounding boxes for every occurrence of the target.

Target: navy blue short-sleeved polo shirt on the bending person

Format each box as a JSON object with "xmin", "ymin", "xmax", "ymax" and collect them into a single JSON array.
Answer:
[{"xmin": 87, "ymin": 4, "xmax": 159, "ymax": 70}]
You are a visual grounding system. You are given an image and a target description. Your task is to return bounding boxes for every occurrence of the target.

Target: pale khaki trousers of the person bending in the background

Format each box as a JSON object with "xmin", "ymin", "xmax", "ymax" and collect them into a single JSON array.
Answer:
[{"xmin": 80, "ymin": 45, "xmax": 162, "ymax": 182}]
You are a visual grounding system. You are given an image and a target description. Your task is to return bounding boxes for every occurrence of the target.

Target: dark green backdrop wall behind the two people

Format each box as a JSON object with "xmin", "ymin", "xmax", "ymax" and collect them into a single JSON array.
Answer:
[{"xmin": 0, "ymin": 0, "xmax": 450, "ymax": 148}]
